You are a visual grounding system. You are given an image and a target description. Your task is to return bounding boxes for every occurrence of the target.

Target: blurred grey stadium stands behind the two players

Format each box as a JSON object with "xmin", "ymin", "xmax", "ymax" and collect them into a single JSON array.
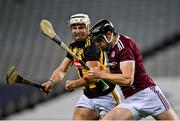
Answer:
[{"xmin": 0, "ymin": 0, "xmax": 180, "ymax": 120}]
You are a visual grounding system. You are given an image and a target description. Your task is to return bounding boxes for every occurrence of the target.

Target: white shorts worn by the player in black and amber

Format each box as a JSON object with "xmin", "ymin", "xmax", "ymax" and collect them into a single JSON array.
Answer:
[{"xmin": 75, "ymin": 88, "xmax": 120, "ymax": 116}]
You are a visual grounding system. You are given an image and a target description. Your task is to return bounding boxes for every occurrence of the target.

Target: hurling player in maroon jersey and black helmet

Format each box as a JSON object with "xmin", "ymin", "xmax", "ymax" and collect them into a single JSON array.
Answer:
[{"xmin": 87, "ymin": 19, "xmax": 178, "ymax": 120}]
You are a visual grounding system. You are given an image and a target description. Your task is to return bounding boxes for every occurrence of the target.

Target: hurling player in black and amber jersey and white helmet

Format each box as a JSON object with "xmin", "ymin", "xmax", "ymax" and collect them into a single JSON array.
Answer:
[{"xmin": 43, "ymin": 13, "xmax": 120, "ymax": 120}]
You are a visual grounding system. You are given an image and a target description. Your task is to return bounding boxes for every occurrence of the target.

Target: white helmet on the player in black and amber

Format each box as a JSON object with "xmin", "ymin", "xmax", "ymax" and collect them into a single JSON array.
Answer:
[{"xmin": 69, "ymin": 13, "xmax": 90, "ymax": 27}]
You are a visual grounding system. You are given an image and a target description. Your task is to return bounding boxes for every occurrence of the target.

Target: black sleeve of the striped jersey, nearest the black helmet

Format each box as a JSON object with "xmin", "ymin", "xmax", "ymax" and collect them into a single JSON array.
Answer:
[{"xmin": 84, "ymin": 44, "xmax": 100, "ymax": 62}]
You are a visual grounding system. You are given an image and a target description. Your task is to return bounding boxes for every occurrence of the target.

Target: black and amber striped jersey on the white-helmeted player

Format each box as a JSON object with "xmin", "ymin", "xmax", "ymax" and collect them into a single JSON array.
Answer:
[{"xmin": 66, "ymin": 37, "xmax": 115, "ymax": 98}]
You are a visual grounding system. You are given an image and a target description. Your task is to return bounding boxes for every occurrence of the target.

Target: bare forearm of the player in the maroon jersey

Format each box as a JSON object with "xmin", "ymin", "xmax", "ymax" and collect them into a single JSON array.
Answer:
[{"xmin": 99, "ymin": 72, "xmax": 133, "ymax": 86}]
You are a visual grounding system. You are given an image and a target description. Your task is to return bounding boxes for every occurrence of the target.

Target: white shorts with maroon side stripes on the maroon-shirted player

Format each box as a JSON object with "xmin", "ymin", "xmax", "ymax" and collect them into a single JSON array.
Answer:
[{"xmin": 117, "ymin": 86, "xmax": 170, "ymax": 120}]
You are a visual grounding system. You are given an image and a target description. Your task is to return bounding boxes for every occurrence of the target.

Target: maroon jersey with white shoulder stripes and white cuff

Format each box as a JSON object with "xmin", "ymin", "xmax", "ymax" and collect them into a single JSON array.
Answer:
[{"xmin": 108, "ymin": 35, "xmax": 155, "ymax": 98}]
